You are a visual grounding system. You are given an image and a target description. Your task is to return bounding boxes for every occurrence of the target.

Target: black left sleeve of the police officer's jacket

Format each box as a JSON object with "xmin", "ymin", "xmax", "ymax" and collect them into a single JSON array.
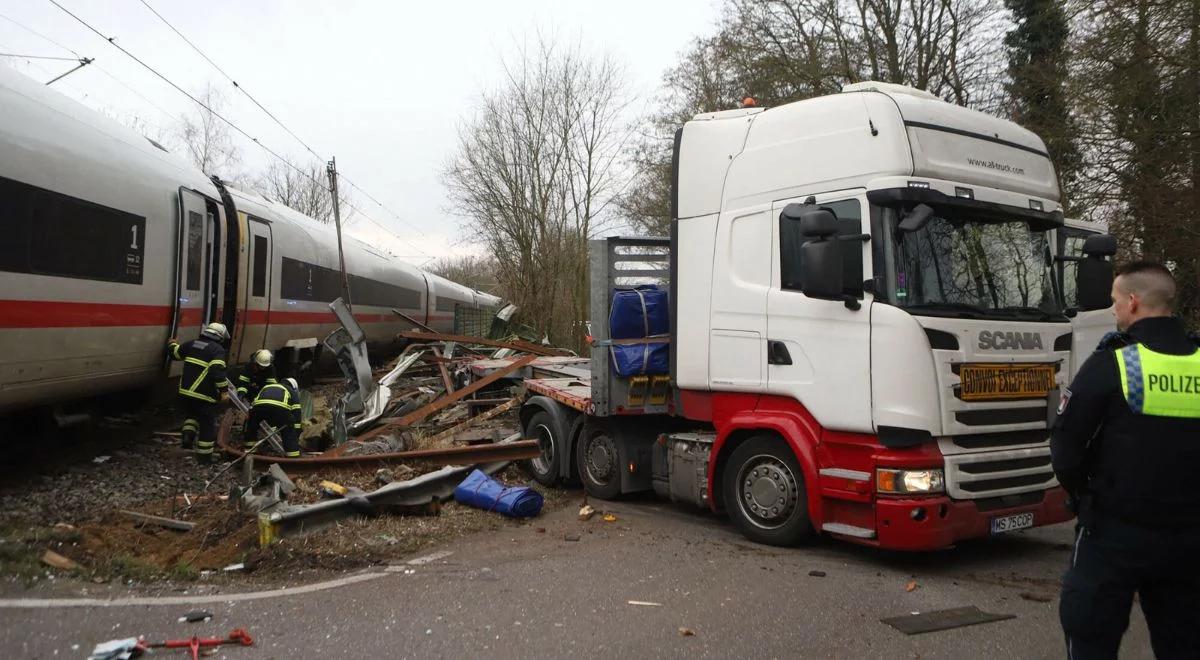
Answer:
[{"xmin": 1050, "ymin": 350, "xmax": 1120, "ymax": 497}]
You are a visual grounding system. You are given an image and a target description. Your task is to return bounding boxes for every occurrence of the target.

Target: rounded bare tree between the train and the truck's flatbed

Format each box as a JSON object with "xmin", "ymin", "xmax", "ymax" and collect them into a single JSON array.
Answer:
[{"xmin": 443, "ymin": 38, "xmax": 629, "ymax": 347}]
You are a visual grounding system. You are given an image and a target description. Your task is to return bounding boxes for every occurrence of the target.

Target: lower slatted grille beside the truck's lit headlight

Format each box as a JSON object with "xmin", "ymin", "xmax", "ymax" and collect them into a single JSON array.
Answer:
[{"xmin": 946, "ymin": 446, "xmax": 1058, "ymax": 499}]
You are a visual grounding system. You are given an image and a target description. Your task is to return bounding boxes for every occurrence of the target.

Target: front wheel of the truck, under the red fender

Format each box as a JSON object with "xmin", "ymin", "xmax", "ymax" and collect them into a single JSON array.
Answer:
[{"xmin": 721, "ymin": 436, "xmax": 812, "ymax": 546}]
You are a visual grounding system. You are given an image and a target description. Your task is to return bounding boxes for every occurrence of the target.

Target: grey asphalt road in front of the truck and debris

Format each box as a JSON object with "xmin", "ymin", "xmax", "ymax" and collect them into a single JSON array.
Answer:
[{"xmin": 0, "ymin": 499, "xmax": 1152, "ymax": 659}]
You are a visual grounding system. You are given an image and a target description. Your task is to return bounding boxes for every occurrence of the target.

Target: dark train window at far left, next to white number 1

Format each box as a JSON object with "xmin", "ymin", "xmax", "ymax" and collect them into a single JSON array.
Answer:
[{"xmin": 0, "ymin": 176, "xmax": 146, "ymax": 284}]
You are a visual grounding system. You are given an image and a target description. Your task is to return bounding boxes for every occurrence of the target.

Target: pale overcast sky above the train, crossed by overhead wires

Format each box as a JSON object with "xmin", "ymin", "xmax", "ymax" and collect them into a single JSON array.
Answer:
[{"xmin": 0, "ymin": 0, "xmax": 719, "ymax": 263}]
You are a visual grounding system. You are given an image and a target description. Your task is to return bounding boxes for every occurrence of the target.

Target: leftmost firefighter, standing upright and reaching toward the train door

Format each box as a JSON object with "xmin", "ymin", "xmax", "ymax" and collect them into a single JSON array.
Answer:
[{"xmin": 167, "ymin": 323, "xmax": 229, "ymax": 464}]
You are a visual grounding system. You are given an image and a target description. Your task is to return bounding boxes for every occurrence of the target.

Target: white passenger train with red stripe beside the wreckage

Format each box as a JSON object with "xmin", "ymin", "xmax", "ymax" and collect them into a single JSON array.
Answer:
[{"xmin": 0, "ymin": 66, "xmax": 500, "ymax": 412}]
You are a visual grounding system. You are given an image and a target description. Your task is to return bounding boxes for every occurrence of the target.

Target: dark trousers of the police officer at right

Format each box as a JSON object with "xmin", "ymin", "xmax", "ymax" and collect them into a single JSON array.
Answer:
[{"xmin": 1058, "ymin": 515, "xmax": 1200, "ymax": 660}]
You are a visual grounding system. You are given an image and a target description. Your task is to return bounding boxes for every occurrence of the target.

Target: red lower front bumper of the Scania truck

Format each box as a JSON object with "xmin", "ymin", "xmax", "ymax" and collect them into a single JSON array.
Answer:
[{"xmin": 851, "ymin": 487, "xmax": 1075, "ymax": 550}]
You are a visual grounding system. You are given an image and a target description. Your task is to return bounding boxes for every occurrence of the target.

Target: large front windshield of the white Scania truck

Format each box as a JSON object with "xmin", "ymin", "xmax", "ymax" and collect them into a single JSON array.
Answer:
[{"xmin": 882, "ymin": 208, "xmax": 1067, "ymax": 320}]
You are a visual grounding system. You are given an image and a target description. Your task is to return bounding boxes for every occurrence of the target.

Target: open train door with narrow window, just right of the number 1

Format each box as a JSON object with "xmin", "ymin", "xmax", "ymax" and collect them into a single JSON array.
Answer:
[{"xmin": 170, "ymin": 188, "xmax": 215, "ymax": 376}]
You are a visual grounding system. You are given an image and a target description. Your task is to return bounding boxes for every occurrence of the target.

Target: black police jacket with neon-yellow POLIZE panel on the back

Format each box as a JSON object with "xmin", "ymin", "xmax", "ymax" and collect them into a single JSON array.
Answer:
[{"xmin": 1050, "ymin": 317, "xmax": 1200, "ymax": 529}]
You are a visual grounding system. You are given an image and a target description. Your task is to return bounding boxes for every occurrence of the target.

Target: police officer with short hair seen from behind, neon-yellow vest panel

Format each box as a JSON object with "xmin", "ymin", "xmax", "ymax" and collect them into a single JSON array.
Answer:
[{"xmin": 1050, "ymin": 262, "xmax": 1200, "ymax": 659}]
